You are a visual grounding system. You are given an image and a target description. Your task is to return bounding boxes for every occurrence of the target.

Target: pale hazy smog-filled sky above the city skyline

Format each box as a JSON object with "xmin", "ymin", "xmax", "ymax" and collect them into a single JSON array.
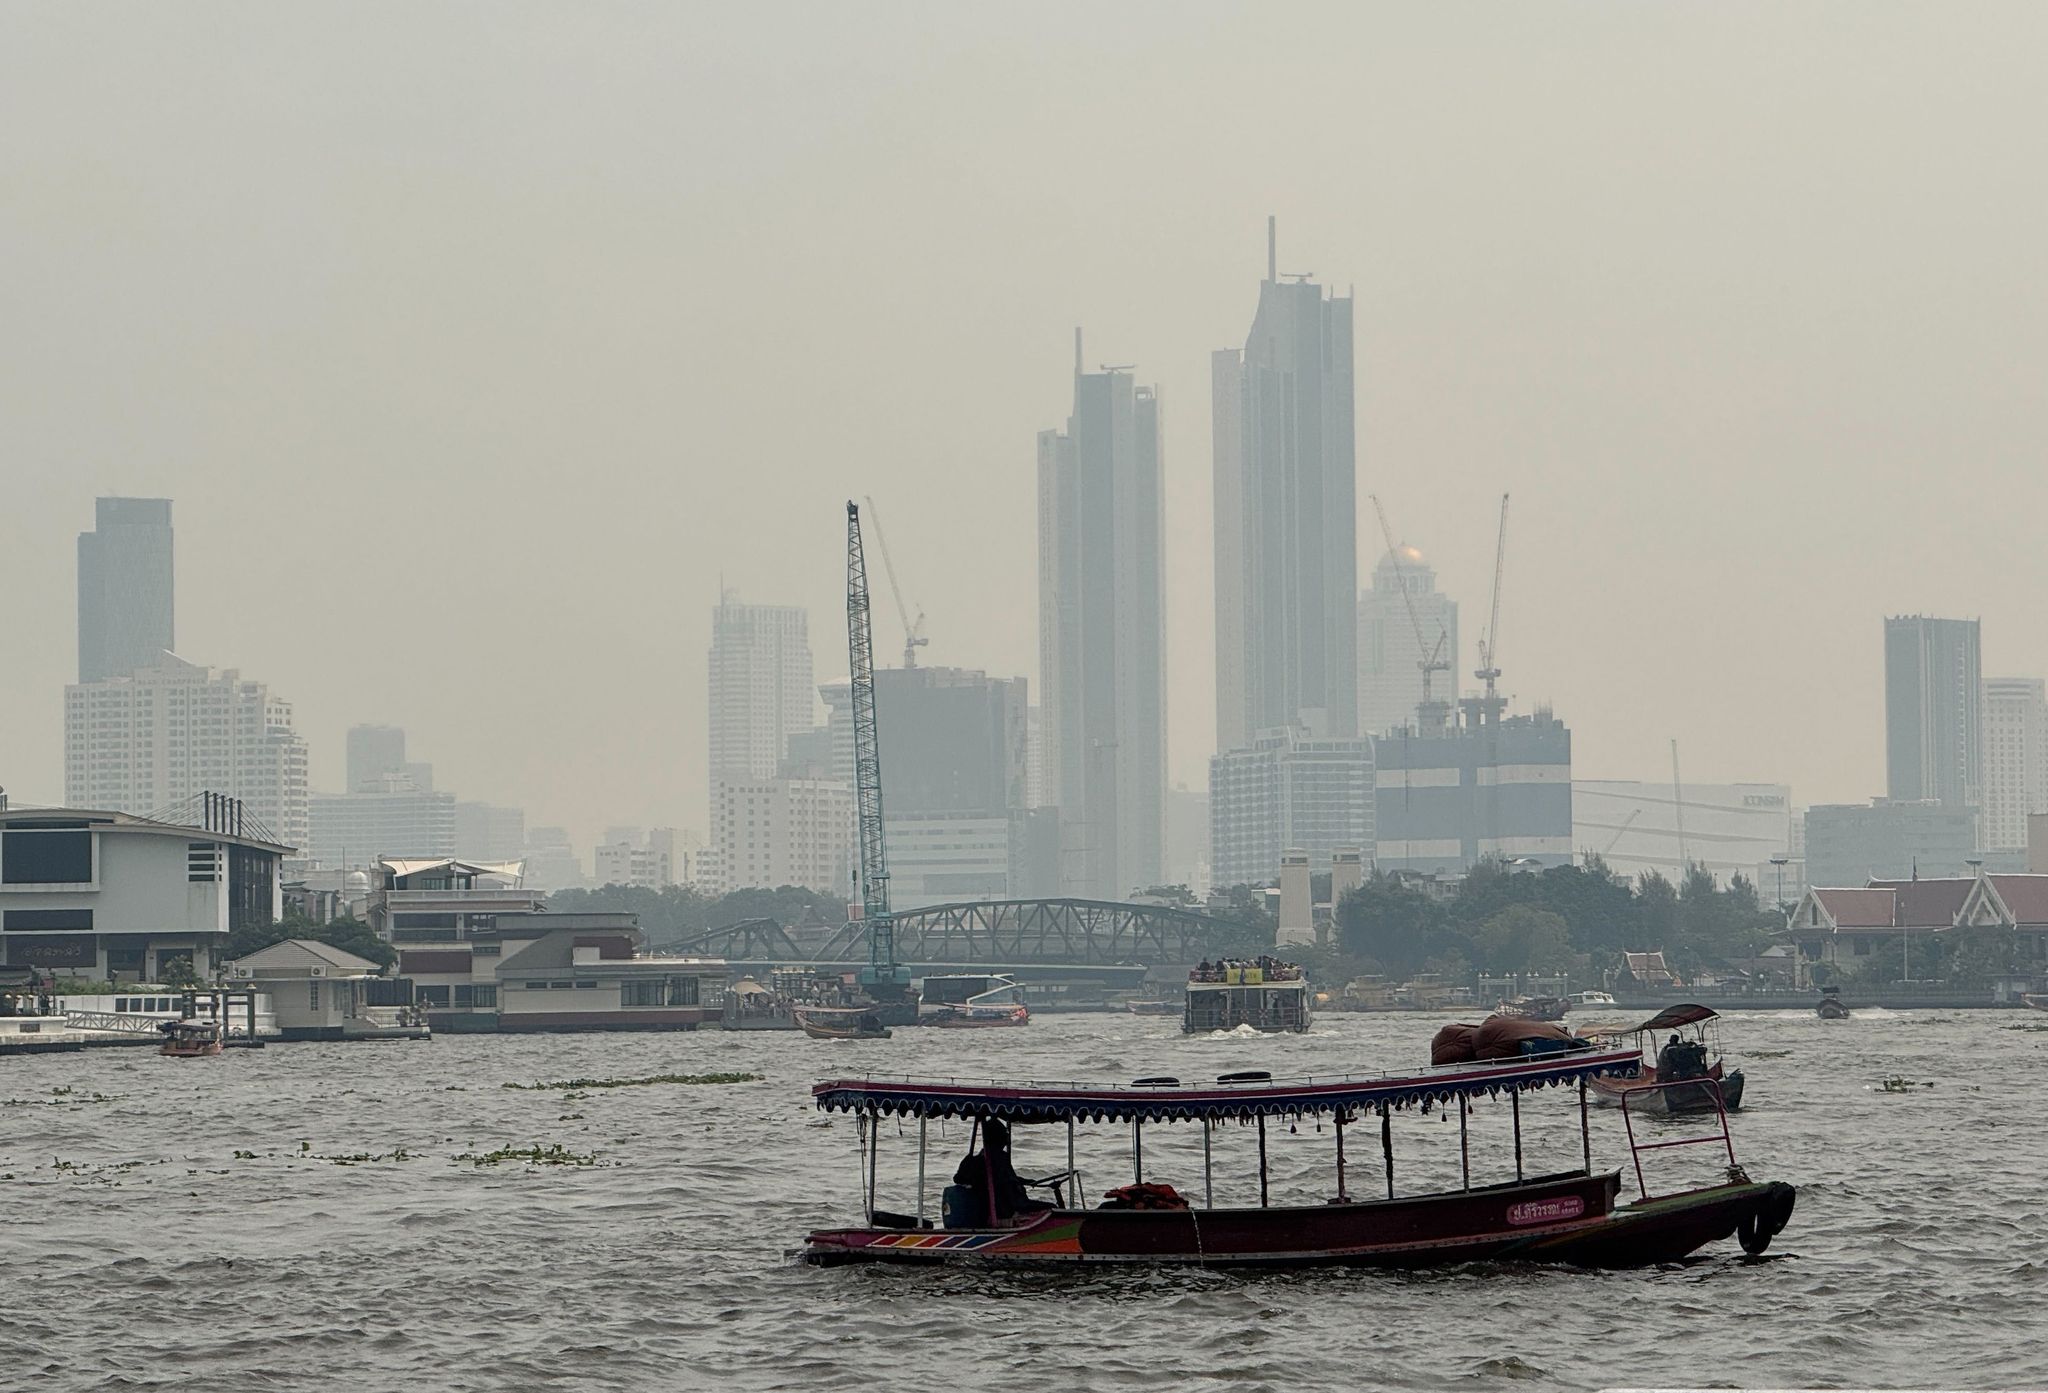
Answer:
[{"xmin": 0, "ymin": 0, "xmax": 2048, "ymax": 848}]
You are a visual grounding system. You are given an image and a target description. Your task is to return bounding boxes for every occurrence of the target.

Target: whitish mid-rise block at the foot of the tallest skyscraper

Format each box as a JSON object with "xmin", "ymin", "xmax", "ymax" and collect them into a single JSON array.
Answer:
[{"xmin": 1208, "ymin": 725, "xmax": 1374, "ymax": 885}]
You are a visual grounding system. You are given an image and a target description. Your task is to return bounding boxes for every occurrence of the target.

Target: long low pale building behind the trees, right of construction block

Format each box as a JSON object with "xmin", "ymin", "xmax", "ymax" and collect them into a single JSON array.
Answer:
[{"xmin": 1571, "ymin": 778, "xmax": 1796, "ymax": 884}]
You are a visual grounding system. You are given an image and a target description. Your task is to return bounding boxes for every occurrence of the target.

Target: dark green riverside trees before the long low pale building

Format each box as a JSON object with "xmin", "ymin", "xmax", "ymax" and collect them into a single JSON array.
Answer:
[{"xmin": 1325, "ymin": 856, "xmax": 1784, "ymax": 983}]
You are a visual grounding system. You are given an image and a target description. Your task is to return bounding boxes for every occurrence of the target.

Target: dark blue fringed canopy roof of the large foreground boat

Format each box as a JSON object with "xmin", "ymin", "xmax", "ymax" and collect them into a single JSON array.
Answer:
[{"xmin": 811, "ymin": 1049, "xmax": 1642, "ymax": 1123}]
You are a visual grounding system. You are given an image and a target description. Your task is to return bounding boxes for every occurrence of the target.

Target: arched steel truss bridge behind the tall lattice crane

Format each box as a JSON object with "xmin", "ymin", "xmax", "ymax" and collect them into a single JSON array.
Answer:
[{"xmin": 672, "ymin": 899, "xmax": 1243, "ymax": 967}]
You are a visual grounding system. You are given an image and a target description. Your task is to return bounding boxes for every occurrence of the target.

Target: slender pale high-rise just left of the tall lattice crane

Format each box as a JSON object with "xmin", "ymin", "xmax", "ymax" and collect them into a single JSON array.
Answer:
[{"xmin": 709, "ymin": 590, "xmax": 817, "ymax": 783}]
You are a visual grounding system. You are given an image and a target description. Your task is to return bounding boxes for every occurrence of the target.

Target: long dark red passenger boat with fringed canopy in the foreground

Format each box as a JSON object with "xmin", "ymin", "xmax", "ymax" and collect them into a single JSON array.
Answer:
[{"xmin": 799, "ymin": 1047, "xmax": 1794, "ymax": 1268}]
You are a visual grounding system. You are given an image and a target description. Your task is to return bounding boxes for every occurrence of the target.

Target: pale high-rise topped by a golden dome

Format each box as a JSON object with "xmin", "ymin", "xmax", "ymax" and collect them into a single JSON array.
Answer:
[{"xmin": 1358, "ymin": 543, "xmax": 1460, "ymax": 735}]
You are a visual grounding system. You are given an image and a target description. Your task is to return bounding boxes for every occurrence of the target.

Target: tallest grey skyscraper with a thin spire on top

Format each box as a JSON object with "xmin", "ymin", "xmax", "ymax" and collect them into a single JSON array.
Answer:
[{"xmin": 1210, "ymin": 219, "xmax": 1358, "ymax": 750}]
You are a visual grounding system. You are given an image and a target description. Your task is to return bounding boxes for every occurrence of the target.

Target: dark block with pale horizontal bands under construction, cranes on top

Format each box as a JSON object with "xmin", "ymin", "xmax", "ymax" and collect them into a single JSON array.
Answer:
[{"xmin": 1372, "ymin": 697, "xmax": 1573, "ymax": 875}]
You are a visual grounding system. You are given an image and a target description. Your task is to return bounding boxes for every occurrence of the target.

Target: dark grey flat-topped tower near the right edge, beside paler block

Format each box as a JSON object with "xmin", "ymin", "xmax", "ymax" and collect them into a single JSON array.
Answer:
[{"xmin": 1884, "ymin": 615, "xmax": 1985, "ymax": 809}]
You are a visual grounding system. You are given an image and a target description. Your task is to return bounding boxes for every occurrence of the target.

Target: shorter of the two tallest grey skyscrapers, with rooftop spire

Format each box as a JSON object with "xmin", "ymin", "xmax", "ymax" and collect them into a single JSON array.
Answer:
[{"xmin": 1038, "ymin": 342, "xmax": 1165, "ymax": 899}]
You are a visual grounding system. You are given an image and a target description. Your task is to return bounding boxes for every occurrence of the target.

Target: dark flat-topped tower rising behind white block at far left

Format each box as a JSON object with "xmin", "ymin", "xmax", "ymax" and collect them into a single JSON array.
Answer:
[{"xmin": 78, "ymin": 498, "xmax": 174, "ymax": 682}]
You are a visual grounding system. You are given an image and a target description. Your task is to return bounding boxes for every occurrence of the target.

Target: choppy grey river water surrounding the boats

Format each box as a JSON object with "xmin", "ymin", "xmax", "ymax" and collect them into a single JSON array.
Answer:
[{"xmin": 0, "ymin": 1012, "xmax": 2048, "ymax": 1393}]
